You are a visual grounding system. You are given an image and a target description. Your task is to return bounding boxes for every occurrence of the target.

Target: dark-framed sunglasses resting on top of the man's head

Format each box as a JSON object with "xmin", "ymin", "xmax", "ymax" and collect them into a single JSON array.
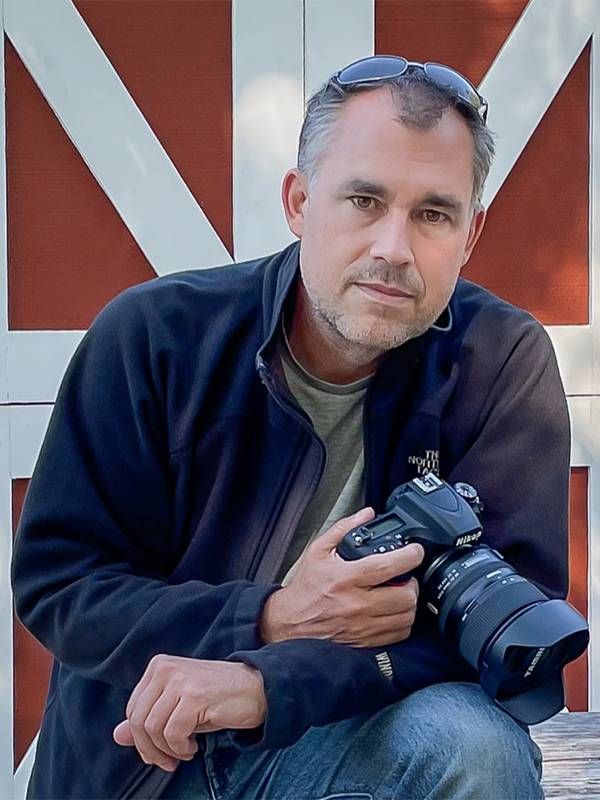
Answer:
[{"xmin": 333, "ymin": 56, "xmax": 488, "ymax": 124}]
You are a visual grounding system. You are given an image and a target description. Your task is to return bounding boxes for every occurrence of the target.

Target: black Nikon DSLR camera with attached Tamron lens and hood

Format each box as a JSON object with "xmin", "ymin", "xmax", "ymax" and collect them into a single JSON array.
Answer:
[{"xmin": 337, "ymin": 472, "xmax": 589, "ymax": 725}]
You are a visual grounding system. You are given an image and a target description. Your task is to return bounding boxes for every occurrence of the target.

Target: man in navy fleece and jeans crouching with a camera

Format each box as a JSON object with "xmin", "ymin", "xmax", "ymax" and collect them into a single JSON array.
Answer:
[{"xmin": 14, "ymin": 57, "xmax": 569, "ymax": 800}]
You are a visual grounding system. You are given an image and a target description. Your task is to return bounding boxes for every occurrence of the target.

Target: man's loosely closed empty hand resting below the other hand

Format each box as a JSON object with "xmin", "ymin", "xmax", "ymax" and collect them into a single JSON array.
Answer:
[{"xmin": 113, "ymin": 655, "xmax": 267, "ymax": 772}]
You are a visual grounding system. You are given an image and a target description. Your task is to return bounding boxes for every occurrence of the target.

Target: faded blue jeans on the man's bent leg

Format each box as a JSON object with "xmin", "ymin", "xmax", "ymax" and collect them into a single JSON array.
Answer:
[{"xmin": 162, "ymin": 683, "xmax": 544, "ymax": 800}]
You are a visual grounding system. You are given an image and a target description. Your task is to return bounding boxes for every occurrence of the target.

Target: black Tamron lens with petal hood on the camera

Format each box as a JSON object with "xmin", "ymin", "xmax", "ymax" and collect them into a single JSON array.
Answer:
[{"xmin": 421, "ymin": 544, "xmax": 587, "ymax": 724}]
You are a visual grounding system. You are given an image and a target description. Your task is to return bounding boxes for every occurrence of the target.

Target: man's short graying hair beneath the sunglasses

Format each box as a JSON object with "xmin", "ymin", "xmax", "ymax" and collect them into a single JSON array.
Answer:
[{"xmin": 298, "ymin": 71, "xmax": 494, "ymax": 208}]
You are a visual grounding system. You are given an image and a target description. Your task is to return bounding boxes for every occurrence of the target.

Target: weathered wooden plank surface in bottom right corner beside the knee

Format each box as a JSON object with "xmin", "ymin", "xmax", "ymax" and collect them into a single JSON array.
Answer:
[{"xmin": 531, "ymin": 712, "xmax": 600, "ymax": 800}]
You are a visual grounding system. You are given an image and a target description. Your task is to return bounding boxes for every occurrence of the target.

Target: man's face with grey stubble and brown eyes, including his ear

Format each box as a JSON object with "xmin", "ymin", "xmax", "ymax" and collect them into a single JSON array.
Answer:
[{"xmin": 284, "ymin": 89, "xmax": 484, "ymax": 352}]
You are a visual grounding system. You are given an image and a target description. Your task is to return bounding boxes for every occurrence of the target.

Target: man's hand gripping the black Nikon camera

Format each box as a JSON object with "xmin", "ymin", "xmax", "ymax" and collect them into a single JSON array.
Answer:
[{"xmin": 261, "ymin": 508, "xmax": 424, "ymax": 647}]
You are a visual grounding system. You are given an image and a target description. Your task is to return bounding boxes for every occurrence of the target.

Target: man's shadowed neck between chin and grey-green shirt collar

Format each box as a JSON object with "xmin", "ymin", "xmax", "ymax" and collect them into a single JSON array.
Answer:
[{"xmin": 286, "ymin": 284, "xmax": 383, "ymax": 384}]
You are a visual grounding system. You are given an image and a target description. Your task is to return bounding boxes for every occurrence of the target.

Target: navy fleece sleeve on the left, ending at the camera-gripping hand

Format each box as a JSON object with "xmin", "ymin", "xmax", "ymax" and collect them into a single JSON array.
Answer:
[{"xmin": 12, "ymin": 290, "xmax": 277, "ymax": 689}]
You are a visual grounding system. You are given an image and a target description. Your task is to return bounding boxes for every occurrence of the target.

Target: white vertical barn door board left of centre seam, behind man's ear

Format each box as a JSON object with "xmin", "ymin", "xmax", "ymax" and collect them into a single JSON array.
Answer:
[{"xmin": 232, "ymin": 0, "xmax": 304, "ymax": 261}]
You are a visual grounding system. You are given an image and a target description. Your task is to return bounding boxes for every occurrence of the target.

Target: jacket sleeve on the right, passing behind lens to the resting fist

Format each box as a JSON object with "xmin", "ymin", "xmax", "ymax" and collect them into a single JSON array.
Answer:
[{"xmin": 230, "ymin": 320, "xmax": 570, "ymax": 748}]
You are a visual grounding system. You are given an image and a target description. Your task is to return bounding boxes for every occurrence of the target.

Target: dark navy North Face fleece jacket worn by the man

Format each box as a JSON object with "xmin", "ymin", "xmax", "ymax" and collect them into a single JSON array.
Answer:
[{"xmin": 13, "ymin": 243, "xmax": 569, "ymax": 798}]
